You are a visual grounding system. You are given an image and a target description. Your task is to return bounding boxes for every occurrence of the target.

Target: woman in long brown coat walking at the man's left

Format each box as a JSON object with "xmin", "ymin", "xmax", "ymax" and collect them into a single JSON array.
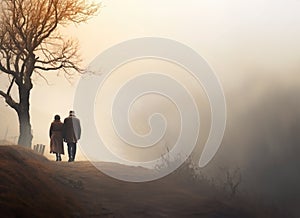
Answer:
[{"xmin": 49, "ymin": 115, "xmax": 65, "ymax": 161}]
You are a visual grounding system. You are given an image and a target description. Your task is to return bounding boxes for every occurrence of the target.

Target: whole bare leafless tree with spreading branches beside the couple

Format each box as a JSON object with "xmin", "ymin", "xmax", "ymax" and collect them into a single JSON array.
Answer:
[{"xmin": 0, "ymin": 0, "xmax": 99, "ymax": 146}]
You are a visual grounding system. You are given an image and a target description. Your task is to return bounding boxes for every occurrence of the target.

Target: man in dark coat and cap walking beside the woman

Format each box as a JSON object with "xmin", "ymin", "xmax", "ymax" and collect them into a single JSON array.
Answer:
[{"xmin": 63, "ymin": 111, "xmax": 81, "ymax": 162}]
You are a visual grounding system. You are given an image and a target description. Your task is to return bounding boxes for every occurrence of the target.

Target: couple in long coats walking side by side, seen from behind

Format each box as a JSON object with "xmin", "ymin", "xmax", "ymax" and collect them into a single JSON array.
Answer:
[{"xmin": 49, "ymin": 111, "xmax": 81, "ymax": 162}]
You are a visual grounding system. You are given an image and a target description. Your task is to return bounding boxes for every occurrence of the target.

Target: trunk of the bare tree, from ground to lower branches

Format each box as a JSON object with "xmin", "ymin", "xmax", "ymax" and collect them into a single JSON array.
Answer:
[{"xmin": 17, "ymin": 87, "xmax": 32, "ymax": 147}]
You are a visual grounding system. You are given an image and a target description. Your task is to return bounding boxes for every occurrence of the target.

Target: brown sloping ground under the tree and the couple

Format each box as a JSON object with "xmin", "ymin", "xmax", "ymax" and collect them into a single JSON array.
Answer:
[{"xmin": 0, "ymin": 146, "xmax": 284, "ymax": 218}]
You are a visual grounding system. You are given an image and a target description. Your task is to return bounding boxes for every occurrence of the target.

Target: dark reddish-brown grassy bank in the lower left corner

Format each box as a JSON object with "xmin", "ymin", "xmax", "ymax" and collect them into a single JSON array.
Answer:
[{"xmin": 0, "ymin": 146, "xmax": 83, "ymax": 217}]
